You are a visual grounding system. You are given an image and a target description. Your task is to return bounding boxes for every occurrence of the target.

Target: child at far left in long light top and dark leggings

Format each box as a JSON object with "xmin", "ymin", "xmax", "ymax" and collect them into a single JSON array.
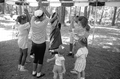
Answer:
[{"xmin": 18, "ymin": 15, "xmax": 30, "ymax": 71}]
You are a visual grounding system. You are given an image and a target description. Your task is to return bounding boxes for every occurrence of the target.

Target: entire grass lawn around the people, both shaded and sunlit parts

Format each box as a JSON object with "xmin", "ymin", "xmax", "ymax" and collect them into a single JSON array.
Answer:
[{"xmin": 0, "ymin": 19, "xmax": 120, "ymax": 79}]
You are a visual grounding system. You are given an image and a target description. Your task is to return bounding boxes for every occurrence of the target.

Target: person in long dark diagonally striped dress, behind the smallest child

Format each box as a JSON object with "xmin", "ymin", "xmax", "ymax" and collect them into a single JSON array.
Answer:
[{"xmin": 49, "ymin": 7, "xmax": 62, "ymax": 54}]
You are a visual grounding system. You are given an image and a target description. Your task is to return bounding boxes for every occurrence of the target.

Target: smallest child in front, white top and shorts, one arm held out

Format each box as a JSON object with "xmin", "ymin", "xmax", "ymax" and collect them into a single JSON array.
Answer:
[{"xmin": 47, "ymin": 45, "xmax": 66, "ymax": 79}]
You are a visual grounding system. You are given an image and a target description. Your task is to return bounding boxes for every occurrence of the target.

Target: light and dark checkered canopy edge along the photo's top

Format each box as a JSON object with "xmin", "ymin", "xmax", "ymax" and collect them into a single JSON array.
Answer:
[{"xmin": 5, "ymin": 0, "xmax": 120, "ymax": 6}]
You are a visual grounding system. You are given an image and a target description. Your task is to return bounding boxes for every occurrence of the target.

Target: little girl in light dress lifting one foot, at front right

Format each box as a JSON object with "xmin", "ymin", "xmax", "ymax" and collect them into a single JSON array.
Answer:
[{"xmin": 71, "ymin": 39, "xmax": 88, "ymax": 79}]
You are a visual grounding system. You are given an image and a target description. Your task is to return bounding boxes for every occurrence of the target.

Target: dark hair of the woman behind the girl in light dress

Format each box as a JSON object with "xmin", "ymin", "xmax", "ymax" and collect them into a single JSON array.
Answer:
[{"xmin": 77, "ymin": 16, "xmax": 90, "ymax": 31}]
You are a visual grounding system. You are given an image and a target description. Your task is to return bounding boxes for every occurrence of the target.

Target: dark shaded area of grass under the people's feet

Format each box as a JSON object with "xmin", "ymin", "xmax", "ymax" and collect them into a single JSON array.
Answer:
[{"xmin": 0, "ymin": 40, "xmax": 120, "ymax": 79}]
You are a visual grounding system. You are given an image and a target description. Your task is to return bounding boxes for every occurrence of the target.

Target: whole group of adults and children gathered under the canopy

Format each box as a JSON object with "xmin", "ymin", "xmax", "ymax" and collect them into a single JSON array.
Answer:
[{"xmin": 17, "ymin": 0, "xmax": 90, "ymax": 79}]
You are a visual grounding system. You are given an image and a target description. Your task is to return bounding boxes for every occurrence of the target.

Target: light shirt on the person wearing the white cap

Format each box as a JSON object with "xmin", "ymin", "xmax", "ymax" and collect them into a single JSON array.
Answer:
[{"xmin": 31, "ymin": 16, "xmax": 49, "ymax": 44}]
